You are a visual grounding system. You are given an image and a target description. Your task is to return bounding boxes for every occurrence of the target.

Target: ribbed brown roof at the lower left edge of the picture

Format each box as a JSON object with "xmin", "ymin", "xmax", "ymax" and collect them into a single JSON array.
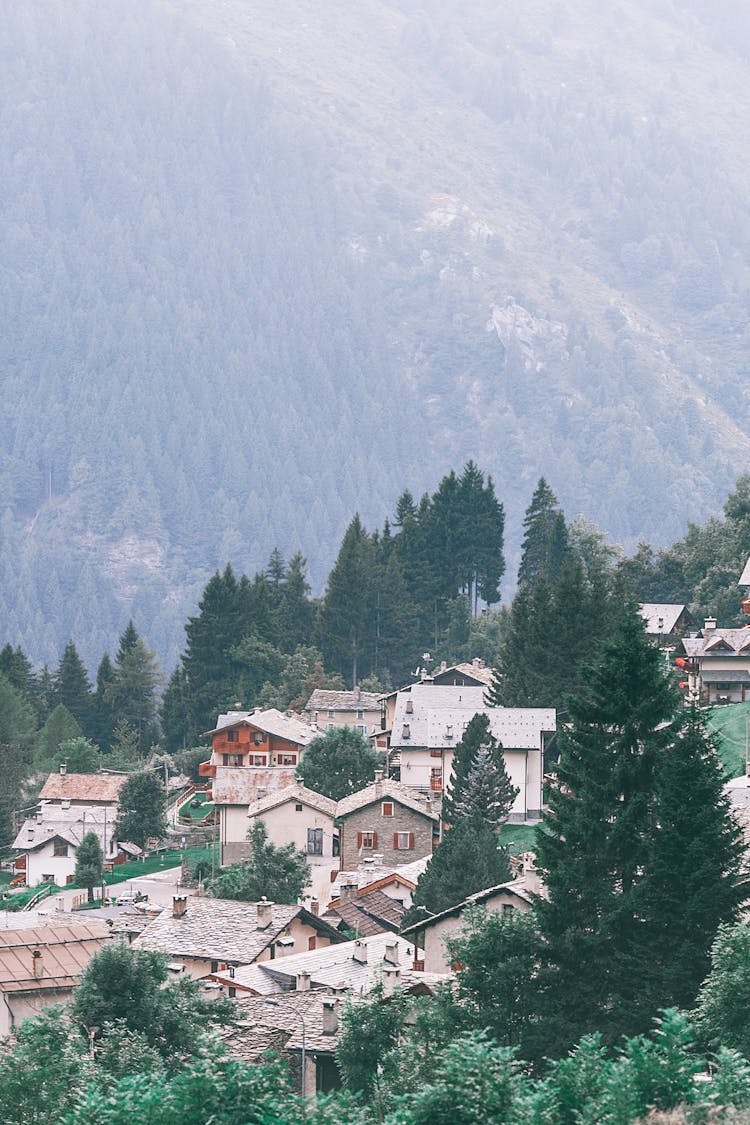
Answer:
[{"xmin": 0, "ymin": 921, "xmax": 111, "ymax": 992}]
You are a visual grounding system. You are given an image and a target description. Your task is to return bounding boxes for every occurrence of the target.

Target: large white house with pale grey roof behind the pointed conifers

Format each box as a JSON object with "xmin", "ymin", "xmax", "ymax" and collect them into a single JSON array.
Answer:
[{"xmin": 389, "ymin": 681, "xmax": 557, "ymax": 822}]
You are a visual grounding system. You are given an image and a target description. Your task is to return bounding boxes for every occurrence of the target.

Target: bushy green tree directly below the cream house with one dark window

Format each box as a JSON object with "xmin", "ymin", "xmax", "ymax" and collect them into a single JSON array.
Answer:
[{"xmin": 208, "ymin": 819, "xmax": 310, "ymax": 902}]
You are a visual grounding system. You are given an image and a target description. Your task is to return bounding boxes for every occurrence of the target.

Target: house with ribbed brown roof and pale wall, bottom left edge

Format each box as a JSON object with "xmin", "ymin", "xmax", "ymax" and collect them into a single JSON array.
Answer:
[{"xmin": 0, "ymin": 920, "xmax": 111, "ymax": 1036}]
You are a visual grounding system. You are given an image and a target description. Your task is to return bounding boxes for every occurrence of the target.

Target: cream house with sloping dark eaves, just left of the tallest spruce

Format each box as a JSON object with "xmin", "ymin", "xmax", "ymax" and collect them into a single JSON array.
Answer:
[{"xmin": 401, "ymin": 866, "xmax": 542, "ymax": 973}]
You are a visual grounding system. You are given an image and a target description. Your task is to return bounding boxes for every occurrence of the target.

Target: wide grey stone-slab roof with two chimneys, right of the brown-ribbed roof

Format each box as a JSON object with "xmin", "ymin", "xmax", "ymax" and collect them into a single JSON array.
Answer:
[{"xmin": 133, "ymin": 896, "xmax": 341, "ymax": 965}]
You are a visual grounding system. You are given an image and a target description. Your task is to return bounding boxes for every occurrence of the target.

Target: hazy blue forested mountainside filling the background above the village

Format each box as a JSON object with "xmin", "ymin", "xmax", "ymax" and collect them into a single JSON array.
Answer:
[{"xmin": 0, "ymin": 0, "xmax": 750, "ymax": 663}]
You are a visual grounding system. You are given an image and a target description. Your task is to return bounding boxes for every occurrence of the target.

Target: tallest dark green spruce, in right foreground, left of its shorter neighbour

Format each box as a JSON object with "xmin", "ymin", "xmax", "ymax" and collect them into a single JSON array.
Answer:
[{"xmin": 536, "ymin": 604, "xmax": 677, "ymax": 1050}]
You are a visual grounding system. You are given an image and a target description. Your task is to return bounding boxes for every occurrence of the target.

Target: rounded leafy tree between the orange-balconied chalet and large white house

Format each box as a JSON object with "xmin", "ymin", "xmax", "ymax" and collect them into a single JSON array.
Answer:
[{"xmin": 297, "ymin": 727, "xmax": 382, "ymax": 801}]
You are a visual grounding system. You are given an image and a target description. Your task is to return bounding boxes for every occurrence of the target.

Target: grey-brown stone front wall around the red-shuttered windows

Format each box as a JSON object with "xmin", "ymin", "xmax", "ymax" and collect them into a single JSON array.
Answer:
[{"xmin": 340, "ymin": 798, "xmax": 433, "ymax": 871}]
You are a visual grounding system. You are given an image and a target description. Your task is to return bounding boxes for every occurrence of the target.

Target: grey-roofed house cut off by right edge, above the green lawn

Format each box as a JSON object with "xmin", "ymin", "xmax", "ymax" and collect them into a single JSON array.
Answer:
[{"xmin": 675, "ymin": 618, "xmax": 750, "ymax": 703}]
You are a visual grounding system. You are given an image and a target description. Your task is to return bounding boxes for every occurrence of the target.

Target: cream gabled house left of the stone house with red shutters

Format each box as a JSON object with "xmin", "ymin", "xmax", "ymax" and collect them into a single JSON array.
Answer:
[{"xmin": 247, "ymin": 783, "xmax": 338, "ymax": 869}]
